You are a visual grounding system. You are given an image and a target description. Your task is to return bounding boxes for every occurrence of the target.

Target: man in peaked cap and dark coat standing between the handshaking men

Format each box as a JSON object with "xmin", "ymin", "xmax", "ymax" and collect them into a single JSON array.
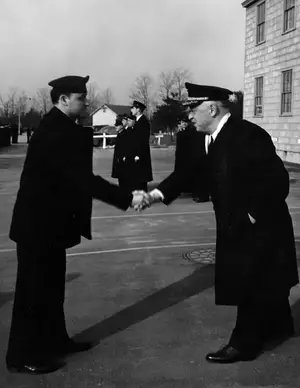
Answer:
[{"xmin": 126, "ymin": 101, "xmax": 153, "ymax": 191}]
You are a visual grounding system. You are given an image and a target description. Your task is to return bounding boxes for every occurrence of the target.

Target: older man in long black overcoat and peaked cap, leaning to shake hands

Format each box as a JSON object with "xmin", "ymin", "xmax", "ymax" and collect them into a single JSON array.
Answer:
[{"xmin": 139, "ymin": 83, "xmax": 298, "ymax": 363}]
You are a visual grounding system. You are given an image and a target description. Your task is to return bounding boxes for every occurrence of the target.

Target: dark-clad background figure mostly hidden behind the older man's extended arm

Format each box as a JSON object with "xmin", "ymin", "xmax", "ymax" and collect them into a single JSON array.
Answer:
[{"xmin": 174, "ymin": 117, "xmax": 209, "ymax": 202}]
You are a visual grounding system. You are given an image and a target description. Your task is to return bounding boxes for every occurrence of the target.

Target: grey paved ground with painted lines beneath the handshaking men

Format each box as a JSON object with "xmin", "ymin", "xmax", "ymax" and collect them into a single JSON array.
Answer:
[{"xmin": 0, "ymin": 139, "xmax": 300, "ymax": 388}]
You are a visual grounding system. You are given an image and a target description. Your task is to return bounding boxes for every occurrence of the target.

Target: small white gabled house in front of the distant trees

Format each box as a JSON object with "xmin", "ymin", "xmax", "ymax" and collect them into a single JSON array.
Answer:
[{"xmin": 91, "ymin": 104, "xmax": 131, "ymax": 126}]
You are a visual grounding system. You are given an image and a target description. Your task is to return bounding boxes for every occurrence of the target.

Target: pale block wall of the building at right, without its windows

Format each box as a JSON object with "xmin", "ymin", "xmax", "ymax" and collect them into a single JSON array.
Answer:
[{"xmin": 242, "ymin": 0, "xmax": 300, "ymax": 163}]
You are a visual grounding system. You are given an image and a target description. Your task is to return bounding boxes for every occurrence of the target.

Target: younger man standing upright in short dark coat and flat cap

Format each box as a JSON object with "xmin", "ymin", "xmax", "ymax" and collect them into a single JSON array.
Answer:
[{"xmin": 6, "ymin": 76, "xmax": 144, "ymax": 374}]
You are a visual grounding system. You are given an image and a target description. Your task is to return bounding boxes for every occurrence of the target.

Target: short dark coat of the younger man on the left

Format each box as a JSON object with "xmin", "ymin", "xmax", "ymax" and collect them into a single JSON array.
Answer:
[{"xmin": 10, "ymin": 107, "xmax": 132, "ymax": 248}]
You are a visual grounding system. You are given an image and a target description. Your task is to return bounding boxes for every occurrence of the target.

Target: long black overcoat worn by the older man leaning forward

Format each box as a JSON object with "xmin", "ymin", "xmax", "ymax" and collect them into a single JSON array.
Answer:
[{"xmin": 158, "ymin": 118, "xmax": 298, "ymax": 305}]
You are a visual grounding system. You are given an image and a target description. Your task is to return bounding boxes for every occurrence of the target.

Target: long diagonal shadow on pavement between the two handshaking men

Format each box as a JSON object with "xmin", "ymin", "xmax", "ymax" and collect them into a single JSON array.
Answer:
[{"xmin": 74, "ymin": 265, "xmax": 214, "ymax": 346}]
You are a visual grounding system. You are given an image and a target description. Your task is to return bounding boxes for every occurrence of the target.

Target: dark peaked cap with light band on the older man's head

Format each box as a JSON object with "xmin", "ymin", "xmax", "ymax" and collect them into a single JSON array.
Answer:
[{"xmin": 184, "ymin": 82, "xmax": 236, "ymax": 105}]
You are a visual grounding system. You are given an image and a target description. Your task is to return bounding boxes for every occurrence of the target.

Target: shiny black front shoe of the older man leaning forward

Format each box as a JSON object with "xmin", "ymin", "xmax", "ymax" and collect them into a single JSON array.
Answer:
[{"xmin": 206, "ymin": 345, "xmax": 258, "ymax": 364}]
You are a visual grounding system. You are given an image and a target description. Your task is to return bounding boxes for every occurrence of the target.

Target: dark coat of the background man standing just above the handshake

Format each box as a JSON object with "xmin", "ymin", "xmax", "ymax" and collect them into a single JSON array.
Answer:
[{"xmin": 124, "ymin": 115, "xmax": 153, "ymax": 182}]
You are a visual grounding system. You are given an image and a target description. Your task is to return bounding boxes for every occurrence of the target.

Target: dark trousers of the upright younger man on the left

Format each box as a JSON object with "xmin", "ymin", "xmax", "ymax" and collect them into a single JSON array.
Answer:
[{"xmin": 6, "ymin": 244, "xmax": 69, "ymax": 365}]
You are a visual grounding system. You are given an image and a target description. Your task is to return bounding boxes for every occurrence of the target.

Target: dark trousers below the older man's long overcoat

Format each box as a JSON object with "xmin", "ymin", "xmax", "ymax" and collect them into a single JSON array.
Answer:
[{"xmin": 229, "ymin": 296, "xmax": 294, "ymax": 353}]
